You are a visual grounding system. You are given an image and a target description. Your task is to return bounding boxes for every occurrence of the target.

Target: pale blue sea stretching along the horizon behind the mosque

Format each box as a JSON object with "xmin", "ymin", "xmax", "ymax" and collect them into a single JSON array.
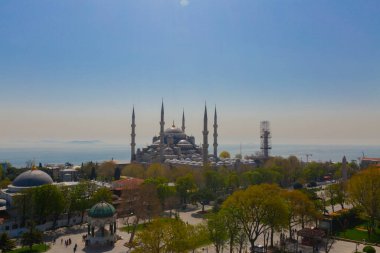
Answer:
[{"xmin": 0, "ymin": 144, "xmax": 380, "ymax": 167}]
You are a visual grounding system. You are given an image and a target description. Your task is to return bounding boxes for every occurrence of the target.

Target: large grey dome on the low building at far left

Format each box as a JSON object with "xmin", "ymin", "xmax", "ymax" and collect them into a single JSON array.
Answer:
[{"xmin": 12, "ymin": 170, "xmax": 53, "ymax": 187}]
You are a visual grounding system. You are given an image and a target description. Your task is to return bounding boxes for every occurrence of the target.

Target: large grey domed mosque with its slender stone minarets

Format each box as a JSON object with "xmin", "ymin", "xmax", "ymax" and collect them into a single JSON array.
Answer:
[{"xmin": 131, "ymin": 102, "xmax": 218, "ymax": 166}]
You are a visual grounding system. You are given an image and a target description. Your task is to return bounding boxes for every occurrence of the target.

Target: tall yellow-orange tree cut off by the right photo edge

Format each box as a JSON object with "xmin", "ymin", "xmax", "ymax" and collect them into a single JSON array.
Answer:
[{"xmin": 348, "ymin": 167, "xmax": 380, "ymax": 237}]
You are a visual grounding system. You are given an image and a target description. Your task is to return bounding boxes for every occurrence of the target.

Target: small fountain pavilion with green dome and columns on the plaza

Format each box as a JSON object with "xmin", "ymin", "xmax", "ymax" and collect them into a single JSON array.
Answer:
[{"xmin": 86, "ymin": 201, "xmax": 118, "ymax": 246}]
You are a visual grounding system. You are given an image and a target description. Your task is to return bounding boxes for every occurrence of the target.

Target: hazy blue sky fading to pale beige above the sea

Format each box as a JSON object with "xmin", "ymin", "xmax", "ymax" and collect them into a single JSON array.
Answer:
[{"xmin": 0, "ymin": 0, "xmax": 380, "ymax": 146}]
